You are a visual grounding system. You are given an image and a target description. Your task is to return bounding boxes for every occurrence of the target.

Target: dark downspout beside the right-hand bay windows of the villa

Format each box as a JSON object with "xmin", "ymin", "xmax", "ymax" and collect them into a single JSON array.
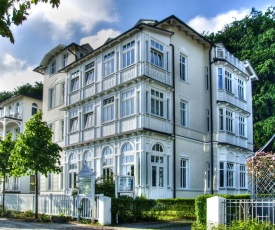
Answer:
[{"xmin": 209, "ymin": 44, "xmax": 214, "ymax": 194}]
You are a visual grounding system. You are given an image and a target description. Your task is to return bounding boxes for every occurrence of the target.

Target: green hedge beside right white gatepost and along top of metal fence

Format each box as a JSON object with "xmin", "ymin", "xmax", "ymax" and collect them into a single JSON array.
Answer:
[{"xmin": 195, "ymin": 194, "xmax": 250, "ymax": 225}]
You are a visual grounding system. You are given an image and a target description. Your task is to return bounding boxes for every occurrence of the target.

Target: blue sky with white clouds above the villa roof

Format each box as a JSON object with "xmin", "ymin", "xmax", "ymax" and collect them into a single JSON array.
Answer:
[{"xmin": 0, "ymin": 0, "xmax": 275, "ymax": 92}]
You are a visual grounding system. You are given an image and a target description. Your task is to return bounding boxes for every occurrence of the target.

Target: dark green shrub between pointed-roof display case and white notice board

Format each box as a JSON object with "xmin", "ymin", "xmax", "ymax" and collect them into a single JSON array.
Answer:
[{"xmin": 95, "ymin": 177, "xmax": 115, "ymax": 197}]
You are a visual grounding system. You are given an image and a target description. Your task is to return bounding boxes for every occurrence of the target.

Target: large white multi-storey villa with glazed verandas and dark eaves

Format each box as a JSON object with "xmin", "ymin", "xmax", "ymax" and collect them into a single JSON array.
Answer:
[{"xmin": 36, "ymin": 16, "xmax": 257, "ymax": 199}]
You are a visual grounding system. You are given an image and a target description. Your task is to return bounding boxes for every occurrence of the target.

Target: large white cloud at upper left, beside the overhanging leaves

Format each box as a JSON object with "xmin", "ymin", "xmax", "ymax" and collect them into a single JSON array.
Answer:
[{"xmin": 28, "ymin": 0, "xmax": 118, "ymax": 40}]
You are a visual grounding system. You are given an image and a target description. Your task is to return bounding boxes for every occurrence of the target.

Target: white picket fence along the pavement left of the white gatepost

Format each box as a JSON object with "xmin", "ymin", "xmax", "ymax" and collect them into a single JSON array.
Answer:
[{"xmin": 0, "ymin": 194, "xmax": 103, "ymax": 220}]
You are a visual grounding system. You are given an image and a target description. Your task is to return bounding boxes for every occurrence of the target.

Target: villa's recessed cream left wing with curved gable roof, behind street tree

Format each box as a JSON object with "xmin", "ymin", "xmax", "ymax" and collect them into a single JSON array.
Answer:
[{"xmin": 34, "ymin": 43, "xmax": 92, "ymax": 194}]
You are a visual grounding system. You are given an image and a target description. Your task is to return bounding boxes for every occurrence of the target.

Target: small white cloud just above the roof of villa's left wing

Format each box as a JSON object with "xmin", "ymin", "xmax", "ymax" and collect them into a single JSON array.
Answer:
[{"xmin": 80, "ymin": 29, "xmax": 120, "ymax": 49}]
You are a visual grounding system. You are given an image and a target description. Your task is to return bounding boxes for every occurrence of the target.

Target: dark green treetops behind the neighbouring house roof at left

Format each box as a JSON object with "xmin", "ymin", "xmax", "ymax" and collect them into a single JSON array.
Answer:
[{"xmin": 0, "ymin": 81, "xmax": 43, "ymax": 103}]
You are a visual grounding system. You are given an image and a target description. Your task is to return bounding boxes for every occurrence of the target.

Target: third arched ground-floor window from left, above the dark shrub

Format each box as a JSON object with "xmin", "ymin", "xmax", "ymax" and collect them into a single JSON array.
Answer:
[{"xmin": 102, "ymin": 146, "xmax": 114, "ymax": 179}]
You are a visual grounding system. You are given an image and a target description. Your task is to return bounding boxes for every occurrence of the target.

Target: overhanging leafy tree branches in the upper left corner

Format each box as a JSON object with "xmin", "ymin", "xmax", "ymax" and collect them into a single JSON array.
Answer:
[{"xmin": 0, "ymin": 0, "xmax": 60, "ymax": 43}]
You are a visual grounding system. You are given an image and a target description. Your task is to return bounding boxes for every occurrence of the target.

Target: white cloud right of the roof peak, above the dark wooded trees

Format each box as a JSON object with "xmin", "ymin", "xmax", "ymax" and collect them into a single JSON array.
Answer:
[{"xmin": 187, "ymin": 9, "xmax": 251, "ymax": 33}]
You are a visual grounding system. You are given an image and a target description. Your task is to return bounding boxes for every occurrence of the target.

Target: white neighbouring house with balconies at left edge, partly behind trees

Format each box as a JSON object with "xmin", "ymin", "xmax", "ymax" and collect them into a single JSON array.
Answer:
[{"xmin": 0, "ymin": 95, "xmax": 42, "ymax": 193}]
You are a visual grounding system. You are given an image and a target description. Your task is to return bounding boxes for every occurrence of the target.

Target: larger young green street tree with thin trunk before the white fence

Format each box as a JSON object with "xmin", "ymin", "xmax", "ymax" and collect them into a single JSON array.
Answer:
[{"xmin": 10, "ymin": 110, "xmax": 62, "ymax": 219}]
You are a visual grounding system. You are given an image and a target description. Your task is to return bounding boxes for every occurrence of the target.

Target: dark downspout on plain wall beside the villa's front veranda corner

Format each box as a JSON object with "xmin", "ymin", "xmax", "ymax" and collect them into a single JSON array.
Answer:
[{"xmin": 170, "ymin": 44, "xmax": 176, "ymax": 198}]
